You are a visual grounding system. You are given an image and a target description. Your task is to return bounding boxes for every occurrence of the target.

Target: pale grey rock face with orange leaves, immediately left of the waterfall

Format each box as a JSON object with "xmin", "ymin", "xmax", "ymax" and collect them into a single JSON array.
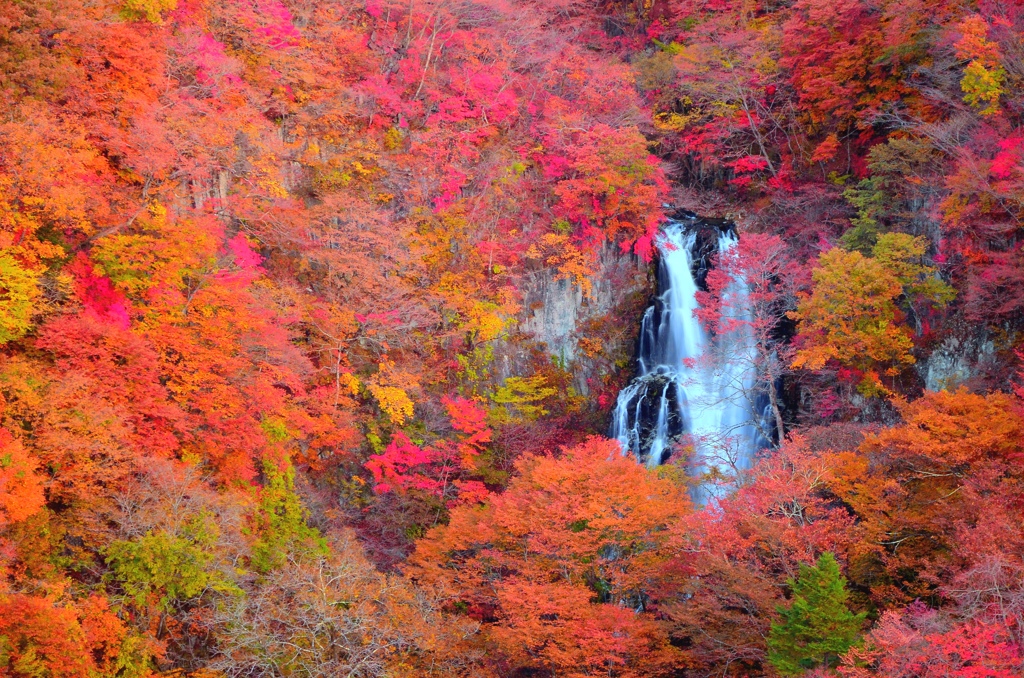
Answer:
[{"xmin": 499, "ymin": 244, "xmax": 654, "ymax": 394}]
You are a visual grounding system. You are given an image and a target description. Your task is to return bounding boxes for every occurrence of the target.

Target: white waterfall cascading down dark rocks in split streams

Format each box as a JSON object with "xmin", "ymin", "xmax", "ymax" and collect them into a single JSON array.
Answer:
[{"xmin": 611, "ymin": 217, "xmax": 765, "ymax": 504}]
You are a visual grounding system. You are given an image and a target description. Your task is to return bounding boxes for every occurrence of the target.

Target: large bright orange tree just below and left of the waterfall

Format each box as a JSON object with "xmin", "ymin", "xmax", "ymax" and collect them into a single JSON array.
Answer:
[{"xmin": 408, "ymin": 438, "xmax": 689, "ymax": 676}]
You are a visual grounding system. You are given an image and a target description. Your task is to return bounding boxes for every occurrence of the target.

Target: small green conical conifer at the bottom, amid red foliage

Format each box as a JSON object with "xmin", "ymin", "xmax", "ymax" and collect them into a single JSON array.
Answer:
[{"xmin": 768, "ymin": 553, "xmax": 864, "ymax": 676}]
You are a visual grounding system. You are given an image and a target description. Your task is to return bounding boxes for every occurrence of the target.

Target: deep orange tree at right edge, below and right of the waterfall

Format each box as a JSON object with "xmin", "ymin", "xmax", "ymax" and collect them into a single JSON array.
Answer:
[{"xmin": 825, "ymin": 390, "xmax": 1024, "ymax": 600}]
